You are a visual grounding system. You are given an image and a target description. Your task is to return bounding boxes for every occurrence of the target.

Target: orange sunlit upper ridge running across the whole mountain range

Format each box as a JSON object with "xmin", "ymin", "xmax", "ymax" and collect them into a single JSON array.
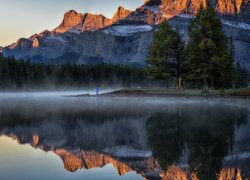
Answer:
[{"xmin": 7, "ymin": 0, "xmax": 250, "ymax": 47}]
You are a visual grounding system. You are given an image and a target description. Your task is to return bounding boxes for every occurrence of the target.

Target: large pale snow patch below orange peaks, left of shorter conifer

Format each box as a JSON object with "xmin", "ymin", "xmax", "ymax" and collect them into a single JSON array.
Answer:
[{"xmin": 103, "ymin": 25, "xmax": 153, "ymax": 36}]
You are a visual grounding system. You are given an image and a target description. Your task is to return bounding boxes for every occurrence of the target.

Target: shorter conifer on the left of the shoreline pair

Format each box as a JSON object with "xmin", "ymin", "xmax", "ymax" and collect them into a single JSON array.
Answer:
[{"xmin": 146, "ymin": 22, "xmax": 184, "ymax": 89}]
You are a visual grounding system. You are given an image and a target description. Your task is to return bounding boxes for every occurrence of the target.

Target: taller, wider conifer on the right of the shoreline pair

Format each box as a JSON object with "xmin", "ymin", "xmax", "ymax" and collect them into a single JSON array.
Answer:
[{"xmin": 186, "ymin": 7, "xmax": 233, "ymax": 89}]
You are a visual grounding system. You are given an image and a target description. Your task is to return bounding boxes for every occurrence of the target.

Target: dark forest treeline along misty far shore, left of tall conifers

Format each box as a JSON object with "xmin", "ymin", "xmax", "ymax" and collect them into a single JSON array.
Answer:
[{"xmin": 0, "ymin": 56, "xmax": 148, "ymax": 90}]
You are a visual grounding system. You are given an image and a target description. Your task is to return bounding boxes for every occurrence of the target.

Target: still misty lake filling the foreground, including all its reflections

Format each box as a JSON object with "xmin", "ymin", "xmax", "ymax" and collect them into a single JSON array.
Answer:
[{"xmin": 0, "ymin": 92, "xmax": 250, "ymax": 180}]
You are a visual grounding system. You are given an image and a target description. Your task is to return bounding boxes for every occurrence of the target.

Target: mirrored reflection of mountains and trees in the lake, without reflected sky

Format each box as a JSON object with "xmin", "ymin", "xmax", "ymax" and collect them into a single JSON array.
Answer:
[{"xmin": 0, "ymin": 101, "xmax": 250, "ymax": 180}]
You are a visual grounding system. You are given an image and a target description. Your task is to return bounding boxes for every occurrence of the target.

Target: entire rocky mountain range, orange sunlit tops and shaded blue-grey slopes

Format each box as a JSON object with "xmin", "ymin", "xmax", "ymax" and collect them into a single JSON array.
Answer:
[{"xmin": 0, "ymin": 0, "xmax": 250, "ymax": 70}]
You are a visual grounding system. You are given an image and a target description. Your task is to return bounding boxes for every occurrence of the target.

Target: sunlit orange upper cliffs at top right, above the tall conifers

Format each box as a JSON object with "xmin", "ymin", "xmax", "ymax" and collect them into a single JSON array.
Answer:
[{"xmin": 127, "ymin": 0, "xmax": 250, "ymax": 24}]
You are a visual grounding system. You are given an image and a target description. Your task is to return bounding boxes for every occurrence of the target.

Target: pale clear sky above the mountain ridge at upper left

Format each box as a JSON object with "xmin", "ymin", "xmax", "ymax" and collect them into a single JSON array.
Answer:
[{"xmin": 0, "ymin": 0, "xmax": 144, "ymax": 46}]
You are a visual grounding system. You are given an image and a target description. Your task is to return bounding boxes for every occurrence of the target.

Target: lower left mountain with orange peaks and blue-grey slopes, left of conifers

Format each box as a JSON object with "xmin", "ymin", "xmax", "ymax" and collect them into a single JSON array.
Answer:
[{"xmin": 4, "ymin": 7, "xmax": 153, "ymax": 64}]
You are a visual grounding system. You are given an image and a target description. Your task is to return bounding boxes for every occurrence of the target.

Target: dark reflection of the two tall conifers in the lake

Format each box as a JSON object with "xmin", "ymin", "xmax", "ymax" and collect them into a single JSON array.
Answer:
[{"xmin": 146, "ymin": 105, "xmax": 248, "ymax": 180}]
